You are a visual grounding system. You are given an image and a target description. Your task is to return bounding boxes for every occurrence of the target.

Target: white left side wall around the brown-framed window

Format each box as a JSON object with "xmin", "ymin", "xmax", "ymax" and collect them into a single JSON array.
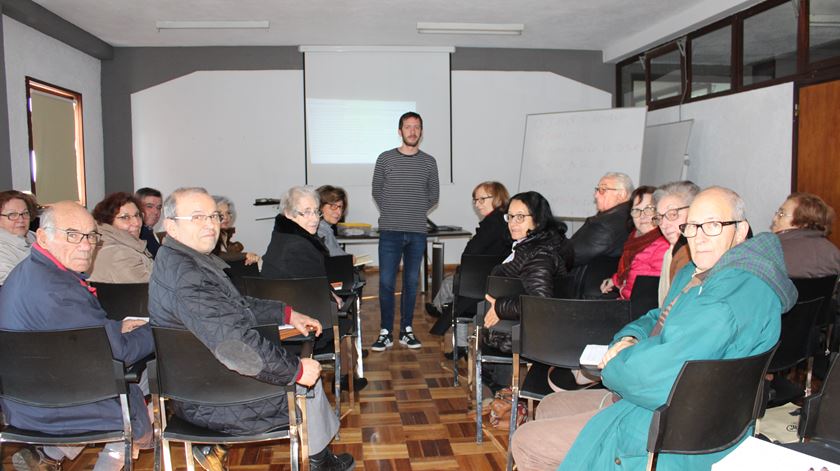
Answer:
[{"xmin": 3, "ymin": 16, "xmax": 105, "ymax": 208}]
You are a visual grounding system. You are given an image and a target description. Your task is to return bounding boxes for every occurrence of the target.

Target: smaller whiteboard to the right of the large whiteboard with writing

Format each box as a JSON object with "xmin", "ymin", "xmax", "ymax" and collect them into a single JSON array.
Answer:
[{"xmin": 639, "ymin": 119, "xmax": 694, "ymax": 186}]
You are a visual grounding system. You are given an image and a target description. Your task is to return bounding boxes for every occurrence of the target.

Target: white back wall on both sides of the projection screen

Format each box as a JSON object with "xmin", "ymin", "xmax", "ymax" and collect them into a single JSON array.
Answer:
[{"xmin": 132, "ymin": 71, "xmax": 611, "ymax": 263}]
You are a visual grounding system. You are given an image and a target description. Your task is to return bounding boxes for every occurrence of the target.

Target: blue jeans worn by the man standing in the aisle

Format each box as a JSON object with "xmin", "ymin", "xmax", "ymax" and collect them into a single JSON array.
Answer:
[{"xmin": 379, "ymin": 231, "xmax": 426, "ymax": 332}]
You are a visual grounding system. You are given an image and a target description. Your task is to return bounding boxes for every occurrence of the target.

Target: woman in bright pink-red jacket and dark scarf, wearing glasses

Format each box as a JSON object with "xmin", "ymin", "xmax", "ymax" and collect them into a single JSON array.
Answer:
[{"xmin": 601, "ymin": 185, "xmax": 668, "ymax": 299}]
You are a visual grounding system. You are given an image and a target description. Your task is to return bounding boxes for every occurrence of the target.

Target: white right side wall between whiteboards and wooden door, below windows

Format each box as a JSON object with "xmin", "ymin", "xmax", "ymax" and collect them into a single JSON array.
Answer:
[{"xmin": 647, "ymin": 83, "xmax": 793, "ymax": 233}]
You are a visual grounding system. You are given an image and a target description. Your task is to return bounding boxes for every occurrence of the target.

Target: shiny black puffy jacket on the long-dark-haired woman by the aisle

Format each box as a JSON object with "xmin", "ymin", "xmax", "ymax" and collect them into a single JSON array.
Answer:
[{"xmin": 491, "ymin": 227, "xmax": 574, "ymax": 320}]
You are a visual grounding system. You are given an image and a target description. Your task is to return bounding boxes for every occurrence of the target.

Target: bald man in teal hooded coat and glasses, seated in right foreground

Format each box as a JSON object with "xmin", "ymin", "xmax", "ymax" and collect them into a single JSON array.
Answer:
[{"xmin": 511, "ymin": 187, "xmax": 797, "ymax": 471}]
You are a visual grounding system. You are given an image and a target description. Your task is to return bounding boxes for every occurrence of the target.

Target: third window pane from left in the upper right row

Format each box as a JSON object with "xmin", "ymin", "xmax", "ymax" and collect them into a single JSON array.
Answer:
[{"xmin": 691, "ymin": 26, "xmax": 732, "ymax": 98}]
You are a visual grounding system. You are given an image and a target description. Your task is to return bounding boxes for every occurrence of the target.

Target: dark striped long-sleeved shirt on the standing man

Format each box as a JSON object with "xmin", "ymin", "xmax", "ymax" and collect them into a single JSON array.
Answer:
[{"xmin": 373, "ymin": 149, "xmax": 440, "ymax": 234}]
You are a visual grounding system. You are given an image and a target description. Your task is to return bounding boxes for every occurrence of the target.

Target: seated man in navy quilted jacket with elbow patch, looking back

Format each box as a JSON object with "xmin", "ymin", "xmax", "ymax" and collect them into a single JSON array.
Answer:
[{"xmin": 149, "ymin": 188, "xmax": 355, "ymax": 471}]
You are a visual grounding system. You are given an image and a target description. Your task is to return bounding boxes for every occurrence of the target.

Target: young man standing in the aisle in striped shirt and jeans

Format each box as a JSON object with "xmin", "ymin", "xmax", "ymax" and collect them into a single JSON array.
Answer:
[{"xmin": 371, "ymin": 111, "xmax": 440, "ymax": 352}]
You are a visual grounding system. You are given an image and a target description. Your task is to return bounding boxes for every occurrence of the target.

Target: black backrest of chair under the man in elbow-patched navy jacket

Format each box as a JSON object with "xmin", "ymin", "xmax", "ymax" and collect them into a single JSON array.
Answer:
[{"xmin": 149, "ymin": 324, "xmax": 286, "ymax": 405}]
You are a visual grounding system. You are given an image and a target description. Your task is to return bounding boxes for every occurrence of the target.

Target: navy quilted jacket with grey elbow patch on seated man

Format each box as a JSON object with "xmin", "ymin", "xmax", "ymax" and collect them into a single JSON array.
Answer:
[{"xmin": 149, "ymin": 237, "xmax": 300, "ymax": 435}]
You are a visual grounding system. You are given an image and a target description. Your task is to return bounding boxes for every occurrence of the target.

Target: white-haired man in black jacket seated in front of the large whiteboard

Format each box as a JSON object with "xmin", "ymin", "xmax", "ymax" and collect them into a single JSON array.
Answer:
[{"xmin": 571, "ymin": 172, "xmax": 633, "ymax": 266}]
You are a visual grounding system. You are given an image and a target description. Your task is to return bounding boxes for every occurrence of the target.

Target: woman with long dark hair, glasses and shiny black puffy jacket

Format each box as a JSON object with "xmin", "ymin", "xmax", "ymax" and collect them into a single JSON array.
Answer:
[{"xmin": 482, "ymin": 191, "xmax": 574, "ymax": 392}]
